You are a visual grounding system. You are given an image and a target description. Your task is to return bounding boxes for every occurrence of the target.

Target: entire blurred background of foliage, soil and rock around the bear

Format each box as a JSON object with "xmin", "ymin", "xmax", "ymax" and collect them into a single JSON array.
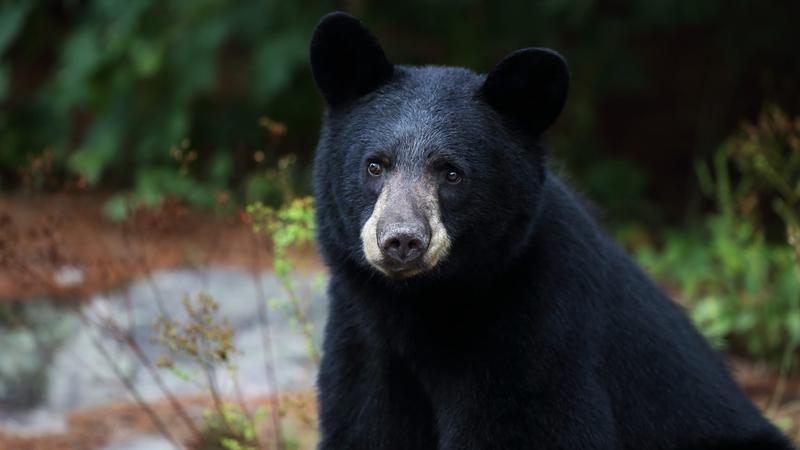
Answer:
[{"xmin": 0, "ymin": 0, "xmax": 800, "ymax": 449}]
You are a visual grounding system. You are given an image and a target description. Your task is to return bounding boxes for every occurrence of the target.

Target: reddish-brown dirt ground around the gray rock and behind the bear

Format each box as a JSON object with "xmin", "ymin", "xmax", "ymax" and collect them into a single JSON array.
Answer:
[{"xmin": 0, "ymin": 194, "xmax": 800, "ymax": 450}]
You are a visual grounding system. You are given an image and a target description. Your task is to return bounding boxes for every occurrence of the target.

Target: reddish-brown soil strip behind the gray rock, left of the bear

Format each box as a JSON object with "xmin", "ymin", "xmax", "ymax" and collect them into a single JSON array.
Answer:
[{"xmin": 0, "ymin": 194, "xmax": 321, "ymax": 301}]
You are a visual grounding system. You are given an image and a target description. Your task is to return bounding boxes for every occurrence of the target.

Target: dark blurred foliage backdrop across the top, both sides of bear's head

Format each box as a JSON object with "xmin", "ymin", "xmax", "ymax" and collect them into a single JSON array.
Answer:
[{"xmin": 0, "ymin": 0, "xmax": 800, "ymax": 227}]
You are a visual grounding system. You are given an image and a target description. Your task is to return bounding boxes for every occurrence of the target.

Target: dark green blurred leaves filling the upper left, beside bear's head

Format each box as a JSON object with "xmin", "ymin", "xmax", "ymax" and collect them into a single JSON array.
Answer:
[{"xmin": 0, "ymin": 0, "xmax": 323, "ymax": 207}]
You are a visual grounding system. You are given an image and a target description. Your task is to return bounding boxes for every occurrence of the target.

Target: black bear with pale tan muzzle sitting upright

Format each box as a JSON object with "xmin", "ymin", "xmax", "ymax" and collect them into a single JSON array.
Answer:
[{"xmin": 310, "ymin": 13, "xmax": 792, "ymax": 450}]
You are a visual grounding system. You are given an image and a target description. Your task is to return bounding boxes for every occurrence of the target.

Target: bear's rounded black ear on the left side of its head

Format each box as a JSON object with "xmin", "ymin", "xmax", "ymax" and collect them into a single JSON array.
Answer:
[{"xmin": 310, "ymin": 12, "xmax": 393, "ymax": 106}]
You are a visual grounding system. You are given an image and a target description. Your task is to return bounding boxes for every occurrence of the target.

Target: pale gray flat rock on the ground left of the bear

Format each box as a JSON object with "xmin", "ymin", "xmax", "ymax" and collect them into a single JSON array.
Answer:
[{"xmin": 0, "ymin": 267, "xmax": 326, "ymax": 440}]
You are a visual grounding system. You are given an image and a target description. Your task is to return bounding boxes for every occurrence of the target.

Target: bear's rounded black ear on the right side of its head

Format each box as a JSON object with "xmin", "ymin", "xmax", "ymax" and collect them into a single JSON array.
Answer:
[{"xmin": 481, "ymin": 48, "xmax": 569, "ymax": 136}]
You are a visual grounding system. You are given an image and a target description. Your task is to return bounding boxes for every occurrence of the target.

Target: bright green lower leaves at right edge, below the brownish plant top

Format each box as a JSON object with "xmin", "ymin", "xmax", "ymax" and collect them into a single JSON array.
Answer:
[{"xmin": 636, "ymin": 215, "xmax": 800, "ymax": 356}]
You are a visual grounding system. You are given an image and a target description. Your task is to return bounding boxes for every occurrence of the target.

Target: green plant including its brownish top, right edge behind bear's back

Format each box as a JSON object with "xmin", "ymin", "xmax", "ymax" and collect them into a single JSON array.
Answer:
[{"xmin": 637, "ymin": 109, "xmax": 800, "ymax": 367}]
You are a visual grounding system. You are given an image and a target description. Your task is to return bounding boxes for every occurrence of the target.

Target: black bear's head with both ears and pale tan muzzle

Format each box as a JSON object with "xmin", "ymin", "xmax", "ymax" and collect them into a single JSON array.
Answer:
[{"xmin": 311, "ymin": 13, "xmax": 569, "ymax": 281}]
